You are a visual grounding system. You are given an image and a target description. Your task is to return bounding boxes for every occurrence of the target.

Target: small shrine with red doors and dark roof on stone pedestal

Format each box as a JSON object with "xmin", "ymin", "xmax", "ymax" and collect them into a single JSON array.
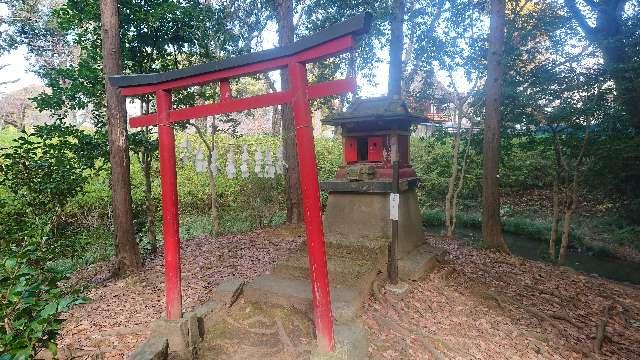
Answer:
[{"xmin": 321, "ymin": 97, "xmax": 438, "ymax": 262}]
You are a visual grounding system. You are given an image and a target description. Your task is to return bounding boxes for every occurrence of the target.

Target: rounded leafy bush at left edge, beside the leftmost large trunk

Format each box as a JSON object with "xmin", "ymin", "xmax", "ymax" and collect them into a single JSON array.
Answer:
[{"xmin": 0, "ymin": 123, "xmax": 105, "ymax": 241}]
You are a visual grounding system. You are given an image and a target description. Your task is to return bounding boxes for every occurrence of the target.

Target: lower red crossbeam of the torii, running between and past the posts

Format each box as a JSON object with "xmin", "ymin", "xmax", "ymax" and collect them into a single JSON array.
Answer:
[{"xmin": 129, "ymin": 79, "xmax": 356, "ymax": 128}]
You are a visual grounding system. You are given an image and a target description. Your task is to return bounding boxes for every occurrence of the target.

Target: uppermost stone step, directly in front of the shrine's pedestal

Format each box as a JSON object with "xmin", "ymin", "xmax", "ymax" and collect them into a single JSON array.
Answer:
[{"xmin": 273, "ymin": 251, "xmax": 378, "ymax": 293}]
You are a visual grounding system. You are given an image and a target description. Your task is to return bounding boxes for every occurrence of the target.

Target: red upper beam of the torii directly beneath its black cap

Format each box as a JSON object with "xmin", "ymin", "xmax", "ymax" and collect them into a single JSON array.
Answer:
[{"xmin": 120, "ymin": 35, "xmax": 355, "ymax": 96}]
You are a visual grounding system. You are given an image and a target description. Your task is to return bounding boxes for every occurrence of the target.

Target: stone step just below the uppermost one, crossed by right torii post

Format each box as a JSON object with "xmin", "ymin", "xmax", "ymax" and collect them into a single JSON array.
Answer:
[{"xmin": 244, "ymin": 274, "xmax": 365, "ymax": 323}]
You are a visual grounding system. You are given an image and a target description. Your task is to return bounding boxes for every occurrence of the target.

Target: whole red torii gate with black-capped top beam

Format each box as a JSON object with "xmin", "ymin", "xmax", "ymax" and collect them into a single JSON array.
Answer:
[{"xmin": 109, "ymin": 14, "xmax": 371, "ymax": 351}]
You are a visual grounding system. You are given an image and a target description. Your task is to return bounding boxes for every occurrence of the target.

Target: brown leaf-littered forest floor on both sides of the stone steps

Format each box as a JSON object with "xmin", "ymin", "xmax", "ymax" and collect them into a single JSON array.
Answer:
[{"xmin": 53, "ymin": 228, "xmax": 640, "ymax": 359}]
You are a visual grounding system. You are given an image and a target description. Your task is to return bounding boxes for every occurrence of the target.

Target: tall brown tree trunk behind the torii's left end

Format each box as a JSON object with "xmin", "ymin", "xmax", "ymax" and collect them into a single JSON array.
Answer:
[{"xmin": 100, "ymin": 0, "xmax": 142, "ymax": 274}]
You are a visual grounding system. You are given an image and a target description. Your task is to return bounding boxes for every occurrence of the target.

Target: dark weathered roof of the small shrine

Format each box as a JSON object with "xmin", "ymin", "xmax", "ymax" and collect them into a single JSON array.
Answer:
[{"xmin": 322, "ymin": 96, "xmax": 429, "ymax": 126}]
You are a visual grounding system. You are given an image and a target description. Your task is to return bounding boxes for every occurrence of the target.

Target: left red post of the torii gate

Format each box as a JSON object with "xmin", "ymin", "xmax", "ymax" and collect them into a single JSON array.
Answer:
[{"xmin": 156, "ymin": 91, "xmax": 182, "ymax": 320}]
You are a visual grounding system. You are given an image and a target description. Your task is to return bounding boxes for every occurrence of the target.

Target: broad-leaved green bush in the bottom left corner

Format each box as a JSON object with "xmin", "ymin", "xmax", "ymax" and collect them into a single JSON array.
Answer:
[{"xmin": 0, "ymin": 238, "xmax": 82, "ymax": 360}]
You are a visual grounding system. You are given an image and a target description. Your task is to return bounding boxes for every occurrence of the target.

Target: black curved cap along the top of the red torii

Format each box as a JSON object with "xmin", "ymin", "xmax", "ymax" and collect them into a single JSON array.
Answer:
[{"xmin": 109, "ymin": 13, "xmax": 371, "ymax": 88}]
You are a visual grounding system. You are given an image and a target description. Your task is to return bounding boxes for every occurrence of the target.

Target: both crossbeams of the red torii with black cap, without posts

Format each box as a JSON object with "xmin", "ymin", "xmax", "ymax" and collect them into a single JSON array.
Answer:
[{"xmin": 109, "ymin": 14, "xmax": 371, "ymax": 128}]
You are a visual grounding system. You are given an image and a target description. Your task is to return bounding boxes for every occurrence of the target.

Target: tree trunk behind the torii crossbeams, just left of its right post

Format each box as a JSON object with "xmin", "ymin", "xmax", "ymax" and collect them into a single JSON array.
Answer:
[{"xmin": 277, "ymin": 0, "xmax": 303, "ymax": 224}]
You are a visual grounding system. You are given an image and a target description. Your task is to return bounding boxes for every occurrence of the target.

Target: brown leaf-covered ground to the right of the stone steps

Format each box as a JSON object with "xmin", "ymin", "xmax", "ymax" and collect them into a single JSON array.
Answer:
[{"xmin": 364, "ymin": 238, "xmax": 640, "ymax": 359}]
